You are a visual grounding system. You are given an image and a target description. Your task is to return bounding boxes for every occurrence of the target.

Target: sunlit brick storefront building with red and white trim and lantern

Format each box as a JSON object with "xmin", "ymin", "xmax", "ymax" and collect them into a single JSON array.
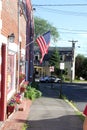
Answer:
[{"xmin": 0, "ymin": 0, "xmax": 32, "ymax": 120}]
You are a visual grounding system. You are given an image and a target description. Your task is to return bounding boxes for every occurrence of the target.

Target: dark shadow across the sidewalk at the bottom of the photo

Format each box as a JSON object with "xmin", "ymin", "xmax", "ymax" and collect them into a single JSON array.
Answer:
[{"xmin": 26, "ymin": 115, "xmax": 83, "ymax": 130}]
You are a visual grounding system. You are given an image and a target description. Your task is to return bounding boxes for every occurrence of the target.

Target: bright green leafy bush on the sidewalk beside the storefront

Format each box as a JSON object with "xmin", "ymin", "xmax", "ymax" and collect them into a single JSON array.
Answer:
[{"xmin": 24, "ymin": 86, "xmax": 42, "ymax": 100}]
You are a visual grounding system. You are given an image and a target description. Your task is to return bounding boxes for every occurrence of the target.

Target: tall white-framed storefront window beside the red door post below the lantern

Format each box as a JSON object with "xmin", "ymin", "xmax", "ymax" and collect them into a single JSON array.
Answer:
[{"xmin": 7, "ymin": 54, "xmax": 14, "ymax": 90}]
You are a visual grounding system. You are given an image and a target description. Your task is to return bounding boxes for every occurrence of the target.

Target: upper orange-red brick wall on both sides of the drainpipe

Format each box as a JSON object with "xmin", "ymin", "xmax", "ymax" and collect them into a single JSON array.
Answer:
[{"xmin": 1, "ymin": 0, "xmax": 26, "ymax": 46}]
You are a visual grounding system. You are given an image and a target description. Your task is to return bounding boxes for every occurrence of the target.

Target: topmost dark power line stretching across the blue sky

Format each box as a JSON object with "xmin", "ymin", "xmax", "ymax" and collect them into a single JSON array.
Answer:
[{"xmin": 33, "ymin": 3, "xmax": 87, "ymax": 6}]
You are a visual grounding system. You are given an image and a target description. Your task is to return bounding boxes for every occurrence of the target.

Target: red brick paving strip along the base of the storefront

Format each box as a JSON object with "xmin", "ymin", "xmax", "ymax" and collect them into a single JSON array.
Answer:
[{"xmin": 0, "ymin": 99, "xmax": 32, "ymax": 130}]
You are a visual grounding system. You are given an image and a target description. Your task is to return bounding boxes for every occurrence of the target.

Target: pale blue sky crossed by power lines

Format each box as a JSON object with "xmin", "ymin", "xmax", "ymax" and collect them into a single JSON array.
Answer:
[{"xmin": 31, "ymin": 0, "xmax": 87, "ymax": 57}]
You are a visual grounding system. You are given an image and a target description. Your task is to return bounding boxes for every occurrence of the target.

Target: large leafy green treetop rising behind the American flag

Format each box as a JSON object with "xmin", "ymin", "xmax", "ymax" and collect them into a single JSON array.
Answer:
[{"xmin": 34, "ymin": 17, "xmax": 59, "ymax": 42}]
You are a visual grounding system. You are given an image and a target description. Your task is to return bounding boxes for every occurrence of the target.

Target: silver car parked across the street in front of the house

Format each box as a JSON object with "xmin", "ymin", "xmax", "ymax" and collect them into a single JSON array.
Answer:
[{"xmin": 40, "ymin": 76, "xmax": 61, "ymax": 83}]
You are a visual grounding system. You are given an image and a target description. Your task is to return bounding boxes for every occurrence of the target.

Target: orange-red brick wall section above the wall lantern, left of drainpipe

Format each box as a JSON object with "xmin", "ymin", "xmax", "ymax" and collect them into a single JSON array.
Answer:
[{"xmin": 1, "ymin": 0, "xmax": 18, "ymax": 43}]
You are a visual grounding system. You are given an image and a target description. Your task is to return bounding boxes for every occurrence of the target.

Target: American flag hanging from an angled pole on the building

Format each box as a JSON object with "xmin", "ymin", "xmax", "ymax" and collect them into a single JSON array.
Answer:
[{"xmin": 36, "ymin": 31, "xmax": 50, "ymax": 63}]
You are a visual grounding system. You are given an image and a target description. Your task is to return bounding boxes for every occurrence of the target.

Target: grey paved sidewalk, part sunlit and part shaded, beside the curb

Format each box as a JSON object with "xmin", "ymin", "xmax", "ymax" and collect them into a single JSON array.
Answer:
[{"xmin": 27, "ymin": 97, "xmax": 83, "ymax": 130}]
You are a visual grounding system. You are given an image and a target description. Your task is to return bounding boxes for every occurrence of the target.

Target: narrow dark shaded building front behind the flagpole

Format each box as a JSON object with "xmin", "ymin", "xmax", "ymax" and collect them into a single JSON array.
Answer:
[{"xmin": 26, "ymin": 0, "xmax": 34, "ymax": 82}]
